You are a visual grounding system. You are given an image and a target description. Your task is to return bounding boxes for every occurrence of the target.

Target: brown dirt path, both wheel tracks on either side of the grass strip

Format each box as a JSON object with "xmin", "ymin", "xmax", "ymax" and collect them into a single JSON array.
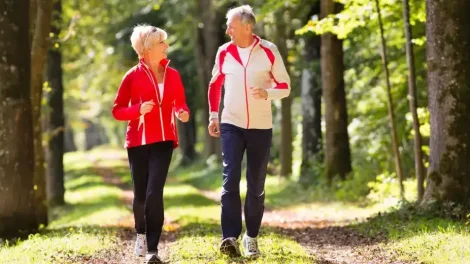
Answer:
[{"xmin": 81, "ymin": 153, "xmax": 410, "ymax": 264}]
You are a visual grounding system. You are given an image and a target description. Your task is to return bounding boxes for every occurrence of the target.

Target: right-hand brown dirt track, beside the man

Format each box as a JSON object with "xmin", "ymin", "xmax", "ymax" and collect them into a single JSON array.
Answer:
[{"xmin": 196, "ymin": 190, "xmax": 412, "ymax": 264}]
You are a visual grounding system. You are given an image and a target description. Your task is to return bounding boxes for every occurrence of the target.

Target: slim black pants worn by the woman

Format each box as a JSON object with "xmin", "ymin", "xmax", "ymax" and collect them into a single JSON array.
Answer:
[{"xmin": 127, "ymin": 141, "xmax": 173, "ymax": 252}]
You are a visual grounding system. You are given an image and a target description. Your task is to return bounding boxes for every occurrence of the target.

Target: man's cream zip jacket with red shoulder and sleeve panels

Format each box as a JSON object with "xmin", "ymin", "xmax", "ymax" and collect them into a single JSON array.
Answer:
[{"xmin": 208, "ymin": 35, "xmax": 290, "ymax": 129}]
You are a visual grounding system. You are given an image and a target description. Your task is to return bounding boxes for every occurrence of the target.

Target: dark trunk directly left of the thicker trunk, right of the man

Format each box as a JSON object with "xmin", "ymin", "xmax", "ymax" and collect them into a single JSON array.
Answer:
[{"xmin": 299, "ymin": 34, "xmax": 322, "ymax": 184}]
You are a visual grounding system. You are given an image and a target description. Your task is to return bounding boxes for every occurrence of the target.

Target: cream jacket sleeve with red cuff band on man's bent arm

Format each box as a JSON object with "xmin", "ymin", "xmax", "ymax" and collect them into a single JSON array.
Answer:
[{"xmin": 266, "ymin": 44, "xmax": 291, "ymax": 100}]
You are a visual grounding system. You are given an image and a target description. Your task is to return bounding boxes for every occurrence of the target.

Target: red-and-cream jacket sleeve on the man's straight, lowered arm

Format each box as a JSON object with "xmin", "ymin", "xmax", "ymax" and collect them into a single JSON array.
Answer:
[{"xmin": 207, "ymin": 47, "xmax": 225, "ymax": 119}]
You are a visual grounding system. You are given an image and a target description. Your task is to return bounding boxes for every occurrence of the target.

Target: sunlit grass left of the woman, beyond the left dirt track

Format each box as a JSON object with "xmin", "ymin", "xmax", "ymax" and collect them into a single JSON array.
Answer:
[{"xmin": 0, "ymin": 151, "xmax": 130, "ymax": 263}]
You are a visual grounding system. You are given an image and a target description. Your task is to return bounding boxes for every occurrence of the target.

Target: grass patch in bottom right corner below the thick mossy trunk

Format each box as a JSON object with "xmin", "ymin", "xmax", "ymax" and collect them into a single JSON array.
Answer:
[{"xmin": 355, "ymin": 206, "xmax": 470, "ymax": 264}]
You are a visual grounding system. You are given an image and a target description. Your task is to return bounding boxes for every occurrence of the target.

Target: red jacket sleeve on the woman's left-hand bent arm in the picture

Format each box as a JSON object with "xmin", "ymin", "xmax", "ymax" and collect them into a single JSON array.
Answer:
[{"xmin": 112, "ymin": 69, "xmax": 140, "ymax": 121}]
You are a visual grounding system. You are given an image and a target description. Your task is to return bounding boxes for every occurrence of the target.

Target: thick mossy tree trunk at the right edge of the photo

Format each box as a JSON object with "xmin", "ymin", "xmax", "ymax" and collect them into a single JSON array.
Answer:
[{"xmin": 423, "ymin": 0, "xmax": 470, "ymax": 204}]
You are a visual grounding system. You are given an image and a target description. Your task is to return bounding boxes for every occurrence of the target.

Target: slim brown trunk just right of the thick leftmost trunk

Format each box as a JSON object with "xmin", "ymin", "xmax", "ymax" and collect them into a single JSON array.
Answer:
[{"xmin": 31, "ymin": 0, "xmax": 52, "ymax": 225}]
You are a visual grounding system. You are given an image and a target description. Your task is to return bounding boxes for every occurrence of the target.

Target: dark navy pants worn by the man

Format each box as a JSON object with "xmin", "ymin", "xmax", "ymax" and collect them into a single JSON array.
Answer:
[{"xmin": 220, "ymin": 124, "xmax": 272, "ymax": 238}]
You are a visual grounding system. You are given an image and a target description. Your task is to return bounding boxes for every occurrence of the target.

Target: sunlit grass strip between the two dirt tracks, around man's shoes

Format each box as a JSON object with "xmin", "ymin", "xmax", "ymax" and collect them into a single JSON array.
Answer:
[{"xmin": 165, "ymin": 184, "xmax": 315, "ymax": 263}]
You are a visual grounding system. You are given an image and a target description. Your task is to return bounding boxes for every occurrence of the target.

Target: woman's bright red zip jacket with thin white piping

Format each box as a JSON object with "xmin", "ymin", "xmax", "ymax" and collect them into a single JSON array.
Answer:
[{"xmin": 112, "ymin": 59, "xmax": 189, "ymax": 148}]
